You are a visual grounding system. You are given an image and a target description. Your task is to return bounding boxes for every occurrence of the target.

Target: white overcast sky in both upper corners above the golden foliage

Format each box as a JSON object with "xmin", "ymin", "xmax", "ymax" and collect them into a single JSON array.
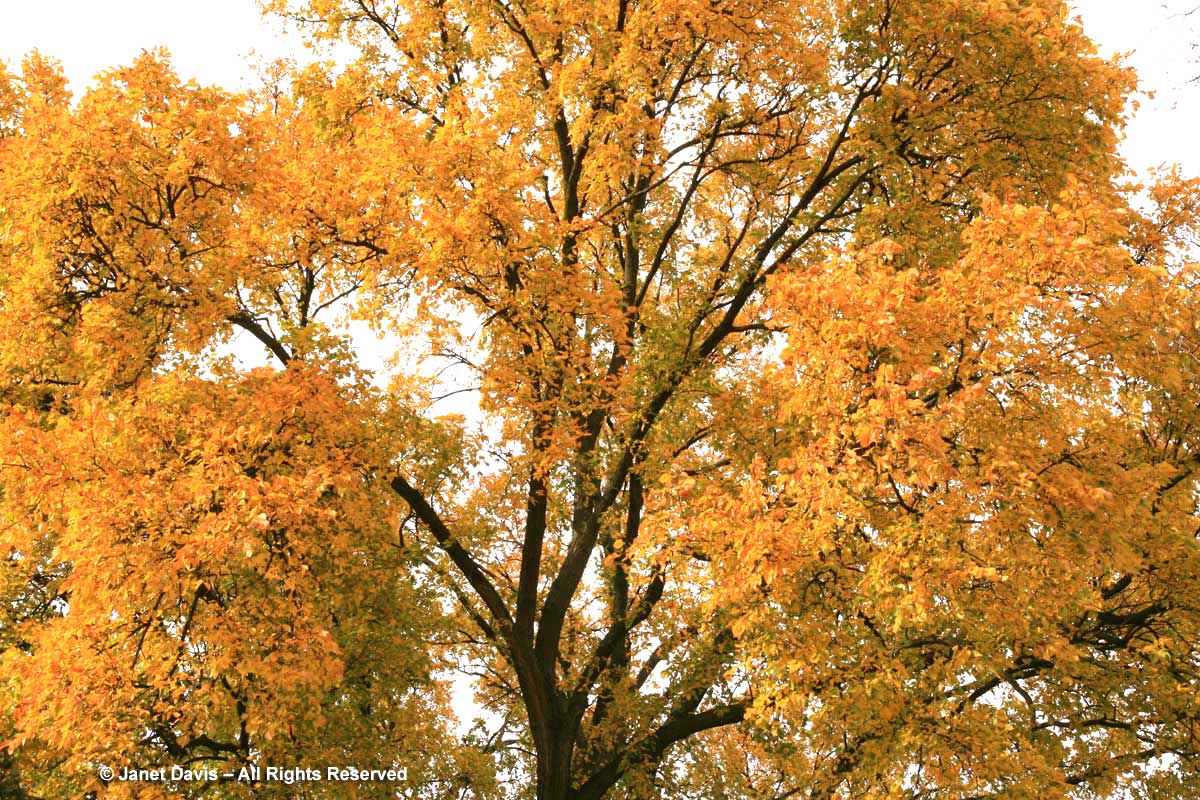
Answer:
[{"xmin": 0, "ymin": 0, "xmax": 1200, "ymax": 174}]
